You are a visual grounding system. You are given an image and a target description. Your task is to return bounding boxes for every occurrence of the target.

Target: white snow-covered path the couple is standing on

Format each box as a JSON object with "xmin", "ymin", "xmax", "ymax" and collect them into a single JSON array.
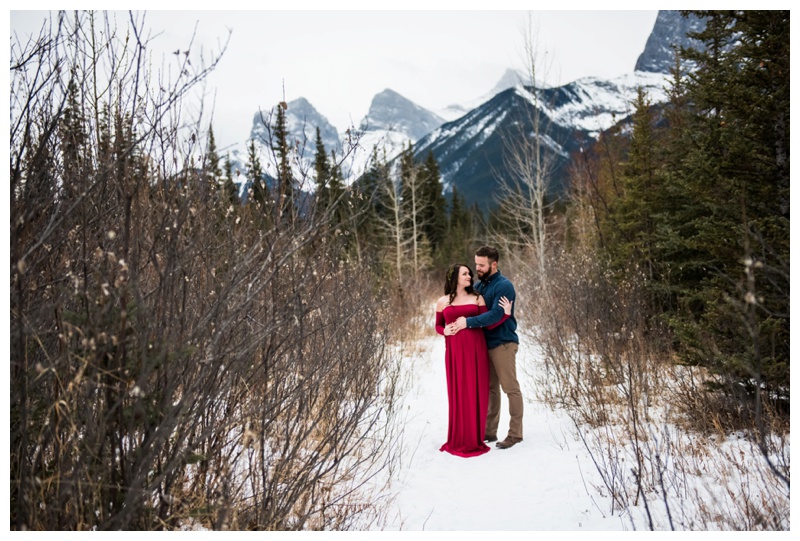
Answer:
[{"xmin": 376, "ymin": 335, "xmax": 632, "ymax": 531}]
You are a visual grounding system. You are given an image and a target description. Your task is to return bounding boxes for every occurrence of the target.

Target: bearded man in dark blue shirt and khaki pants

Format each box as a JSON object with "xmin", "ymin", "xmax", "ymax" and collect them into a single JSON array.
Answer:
[{"xmin": 452, "ymin": 246, "xmax": 522, "ymax": 449}]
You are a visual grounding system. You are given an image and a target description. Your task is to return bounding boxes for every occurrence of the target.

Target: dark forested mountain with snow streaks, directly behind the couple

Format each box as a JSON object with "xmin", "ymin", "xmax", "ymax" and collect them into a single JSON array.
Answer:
[{"xmin": 413, "ymin": 72, "xmax": 666, "ymax": 210}]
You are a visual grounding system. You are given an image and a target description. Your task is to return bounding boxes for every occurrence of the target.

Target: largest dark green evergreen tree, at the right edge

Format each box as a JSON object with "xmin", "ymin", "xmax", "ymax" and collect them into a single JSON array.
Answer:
[{"xmin": 665, "ymin": 11, "xmax": 789, "ymax": 389}]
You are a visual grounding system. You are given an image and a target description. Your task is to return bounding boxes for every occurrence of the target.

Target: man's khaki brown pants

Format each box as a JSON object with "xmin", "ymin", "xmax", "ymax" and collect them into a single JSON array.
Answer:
[{"xmin": 486, "ymin": 342, "xmax": 522, "ymax": 439}]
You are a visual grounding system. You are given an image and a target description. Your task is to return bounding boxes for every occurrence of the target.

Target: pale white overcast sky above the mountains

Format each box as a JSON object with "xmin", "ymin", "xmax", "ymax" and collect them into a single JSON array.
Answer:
[{"xmin": 10, "ymin": 6, "xmax": 658, "ymax": 152}]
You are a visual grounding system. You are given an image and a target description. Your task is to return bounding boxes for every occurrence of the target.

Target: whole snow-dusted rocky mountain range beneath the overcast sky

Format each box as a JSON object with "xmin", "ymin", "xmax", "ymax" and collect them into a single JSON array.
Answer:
[{"xmin": 233, "ymin": 10, "xmax": 703, "ymax": 211}]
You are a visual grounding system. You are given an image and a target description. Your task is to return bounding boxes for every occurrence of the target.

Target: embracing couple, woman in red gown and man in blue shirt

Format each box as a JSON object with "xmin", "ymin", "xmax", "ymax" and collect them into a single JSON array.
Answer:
[{"xmin": 436, "ymin": 246, "xmax": 523, "ymax": 457}]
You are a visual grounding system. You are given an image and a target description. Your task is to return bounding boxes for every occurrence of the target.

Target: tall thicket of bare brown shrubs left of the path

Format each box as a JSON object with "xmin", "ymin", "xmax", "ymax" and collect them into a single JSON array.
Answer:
[{"xmin": 9, "ymin": 12, "xmax": 432, "ymax": 530}]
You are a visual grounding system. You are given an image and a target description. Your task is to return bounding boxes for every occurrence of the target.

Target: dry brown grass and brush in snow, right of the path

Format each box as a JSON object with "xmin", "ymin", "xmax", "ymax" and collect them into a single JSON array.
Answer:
[{"xmin": 520, "ymin": 250, "xmax": 790, "ymax": 530}]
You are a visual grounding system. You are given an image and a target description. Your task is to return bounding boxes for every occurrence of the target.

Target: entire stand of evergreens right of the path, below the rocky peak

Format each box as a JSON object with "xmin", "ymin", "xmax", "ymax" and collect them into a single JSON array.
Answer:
[{"xmin": 574, "ymin": 11, "xmax": 790, "ymax": 405}]
